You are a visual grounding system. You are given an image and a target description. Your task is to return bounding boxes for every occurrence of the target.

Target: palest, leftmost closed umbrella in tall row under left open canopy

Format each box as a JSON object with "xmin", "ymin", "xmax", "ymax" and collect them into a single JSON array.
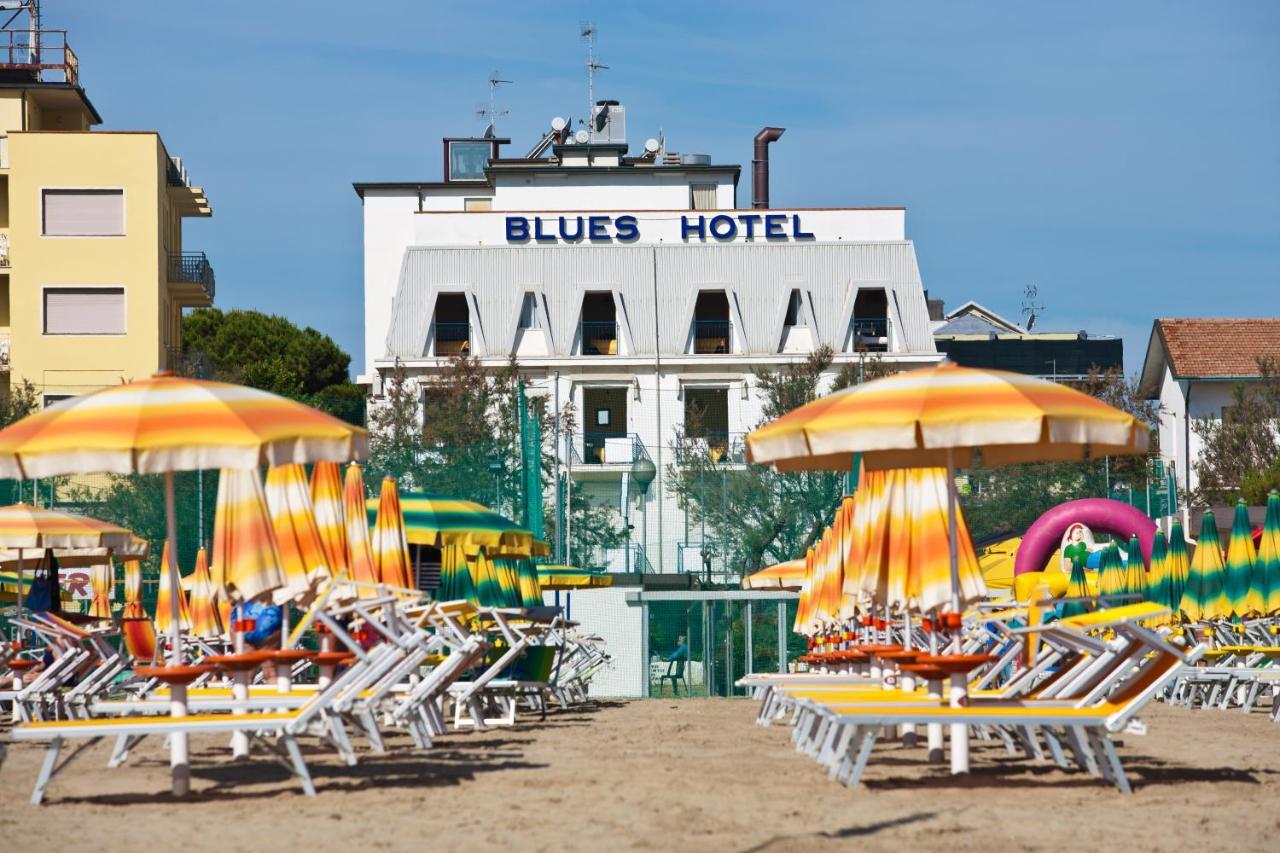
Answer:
[{"xmin": 211, "ymin": 469, "xmax": 285, "ymax": 602}]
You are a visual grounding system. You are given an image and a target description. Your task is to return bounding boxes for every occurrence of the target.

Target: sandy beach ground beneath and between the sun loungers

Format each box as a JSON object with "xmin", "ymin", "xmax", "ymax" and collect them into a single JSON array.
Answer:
[{"xmin": 0, "ymin": 699, "xmax": 1280, "ymax": 853}]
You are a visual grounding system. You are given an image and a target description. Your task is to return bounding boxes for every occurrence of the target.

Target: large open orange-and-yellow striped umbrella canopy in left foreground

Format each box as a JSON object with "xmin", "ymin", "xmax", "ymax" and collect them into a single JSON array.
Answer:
[{"xmin": 0, "ymin": 374, "xmax": 369, "ymax": 478}]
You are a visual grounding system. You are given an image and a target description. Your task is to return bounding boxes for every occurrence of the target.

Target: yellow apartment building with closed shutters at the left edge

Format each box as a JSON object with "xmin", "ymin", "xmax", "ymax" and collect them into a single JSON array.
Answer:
[{"xmin": 0, "ymin": 29, "xmax": 214, "ymax": 405}]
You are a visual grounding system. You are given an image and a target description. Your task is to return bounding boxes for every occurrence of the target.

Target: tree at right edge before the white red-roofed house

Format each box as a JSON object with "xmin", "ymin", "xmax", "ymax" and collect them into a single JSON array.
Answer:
[{"xmin": 1192, "ymin": 357, "xmax": 1280, "ymax": 506}]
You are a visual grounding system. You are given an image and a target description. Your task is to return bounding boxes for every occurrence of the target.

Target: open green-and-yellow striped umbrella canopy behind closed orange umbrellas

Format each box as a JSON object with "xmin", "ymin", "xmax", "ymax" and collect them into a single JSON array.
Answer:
[{"xmin": 386, "ymin": 492, "xmax": 550, "ymax": 557}]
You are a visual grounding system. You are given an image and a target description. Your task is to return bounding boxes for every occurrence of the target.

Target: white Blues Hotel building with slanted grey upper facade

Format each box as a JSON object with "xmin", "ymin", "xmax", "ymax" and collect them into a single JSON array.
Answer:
[{"xmin": 355, "ymin": 101, "xmax": 940, "ymax": 573}]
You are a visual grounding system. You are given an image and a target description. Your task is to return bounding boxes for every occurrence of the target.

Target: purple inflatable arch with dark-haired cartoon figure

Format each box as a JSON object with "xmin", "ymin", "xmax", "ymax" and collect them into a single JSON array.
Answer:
[{"xmin": 1014, "ymin": 498, "xmax": 1156, "ymax": 601}]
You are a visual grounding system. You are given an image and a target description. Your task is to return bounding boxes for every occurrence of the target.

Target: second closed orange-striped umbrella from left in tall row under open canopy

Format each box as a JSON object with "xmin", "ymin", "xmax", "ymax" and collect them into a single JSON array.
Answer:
[{"xmin": 266, "ymin": 462, "xmax": 330, "ymax": 605}]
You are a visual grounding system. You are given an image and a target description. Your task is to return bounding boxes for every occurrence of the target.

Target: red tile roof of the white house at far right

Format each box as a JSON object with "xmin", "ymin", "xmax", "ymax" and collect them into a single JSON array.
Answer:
[{"xmin": 1156, "ymin": 318, "xmax": 1280, "ymax": 377}]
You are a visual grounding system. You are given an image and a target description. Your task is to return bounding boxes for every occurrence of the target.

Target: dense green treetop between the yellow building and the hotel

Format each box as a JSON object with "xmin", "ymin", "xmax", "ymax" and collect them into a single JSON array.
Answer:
[{"xmin": 182, "ymin": 309, "xmax": 353, "ymax": 397}]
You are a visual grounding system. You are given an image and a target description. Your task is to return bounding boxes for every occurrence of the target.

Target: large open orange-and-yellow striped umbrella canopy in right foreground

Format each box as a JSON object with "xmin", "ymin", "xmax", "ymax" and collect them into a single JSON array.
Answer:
[{"xmin": 746, "ymin": 361, "xmax": 1149, "ymax": 470}]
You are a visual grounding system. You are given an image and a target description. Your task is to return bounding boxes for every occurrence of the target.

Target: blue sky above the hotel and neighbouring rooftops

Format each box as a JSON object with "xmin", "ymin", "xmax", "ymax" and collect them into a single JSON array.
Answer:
[{"xmin": 62, "ymin": 0, "xmax": 1280, "ymax": 373}]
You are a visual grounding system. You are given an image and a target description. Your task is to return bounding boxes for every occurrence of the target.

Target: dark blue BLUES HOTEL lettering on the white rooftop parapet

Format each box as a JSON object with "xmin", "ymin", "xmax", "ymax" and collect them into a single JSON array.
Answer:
[{"xmin": 507, "ymin": 213, "xmax": 814, "ymax": 243}]
